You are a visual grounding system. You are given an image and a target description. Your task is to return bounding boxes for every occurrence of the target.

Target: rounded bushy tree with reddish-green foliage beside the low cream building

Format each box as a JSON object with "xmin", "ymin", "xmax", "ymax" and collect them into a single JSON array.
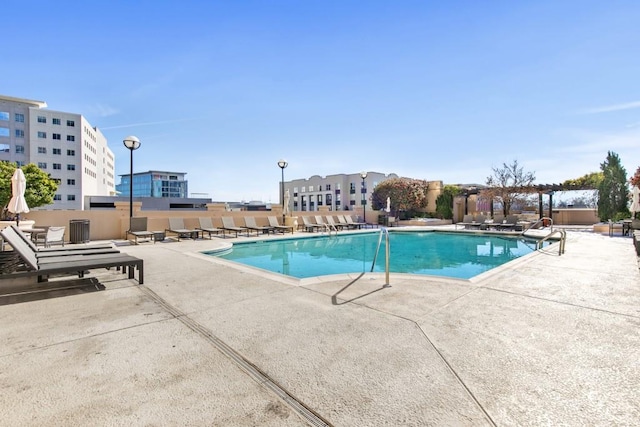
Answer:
[{"xmin": 371, "ymin": 178, "xmax": 429, "ymax": 215}]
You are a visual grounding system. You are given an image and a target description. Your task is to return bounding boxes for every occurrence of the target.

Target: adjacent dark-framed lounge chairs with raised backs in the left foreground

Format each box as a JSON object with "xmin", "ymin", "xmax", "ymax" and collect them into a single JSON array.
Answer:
[{"xmin": 0, "ymin": 225, "xmax": 144, "ymax": 284}]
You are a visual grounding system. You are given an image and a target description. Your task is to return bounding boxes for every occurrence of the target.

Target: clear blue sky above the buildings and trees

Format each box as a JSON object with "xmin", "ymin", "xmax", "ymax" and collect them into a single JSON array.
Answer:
[{"xmin": 0, "ymin": 0, "xmax": 640, "ymax": 202}]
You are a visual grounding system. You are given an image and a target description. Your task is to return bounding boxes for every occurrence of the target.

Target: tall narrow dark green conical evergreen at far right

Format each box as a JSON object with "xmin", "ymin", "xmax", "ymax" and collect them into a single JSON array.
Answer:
[{"xmin": 598, "ymin": 151, "xmax": 630, "ymax": 221}]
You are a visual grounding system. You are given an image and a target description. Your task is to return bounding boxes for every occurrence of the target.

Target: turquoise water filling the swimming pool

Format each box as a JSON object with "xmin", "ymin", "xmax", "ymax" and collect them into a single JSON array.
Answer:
[{"xmin": 209, "ymin": 232, "xmax": 535, "ymax": 279}]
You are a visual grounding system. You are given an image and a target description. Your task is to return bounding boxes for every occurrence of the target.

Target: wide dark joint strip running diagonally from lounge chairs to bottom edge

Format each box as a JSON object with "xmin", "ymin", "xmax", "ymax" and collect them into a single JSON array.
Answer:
[{"xmin": 139, "ymin": 285, "xmax": 332, "ymax": 427}]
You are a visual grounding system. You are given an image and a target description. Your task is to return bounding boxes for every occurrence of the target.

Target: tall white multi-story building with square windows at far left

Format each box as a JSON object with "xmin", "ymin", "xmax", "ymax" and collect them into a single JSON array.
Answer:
[{"xmin": 0, "ymin": 95, "xmax": 115, "ymax": 210}]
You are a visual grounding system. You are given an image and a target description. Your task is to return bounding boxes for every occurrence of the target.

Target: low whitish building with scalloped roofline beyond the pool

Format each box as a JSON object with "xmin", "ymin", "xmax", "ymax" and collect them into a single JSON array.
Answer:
[{"xmin": 280, "ymin": 172, "xmax": 398, "ymax": 212}]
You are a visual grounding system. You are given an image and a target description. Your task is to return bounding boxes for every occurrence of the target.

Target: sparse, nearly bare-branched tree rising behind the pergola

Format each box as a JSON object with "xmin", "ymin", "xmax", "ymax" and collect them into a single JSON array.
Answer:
[{"xmin": 481, "ymin": 160, "xmax": 536, "ymax": 215}]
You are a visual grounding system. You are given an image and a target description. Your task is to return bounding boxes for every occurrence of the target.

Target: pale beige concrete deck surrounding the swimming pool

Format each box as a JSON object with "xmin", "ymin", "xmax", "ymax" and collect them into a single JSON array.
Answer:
[{"xmin": 0, "ymin": 226, "xmax": 640, "ymax": 426}]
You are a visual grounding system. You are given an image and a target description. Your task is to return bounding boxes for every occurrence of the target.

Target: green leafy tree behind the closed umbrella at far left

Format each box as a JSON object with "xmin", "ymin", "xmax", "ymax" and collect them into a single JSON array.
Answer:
[{"xmin": 0, "ymin": 161, "xmax": 58, "ymax": 219}]
